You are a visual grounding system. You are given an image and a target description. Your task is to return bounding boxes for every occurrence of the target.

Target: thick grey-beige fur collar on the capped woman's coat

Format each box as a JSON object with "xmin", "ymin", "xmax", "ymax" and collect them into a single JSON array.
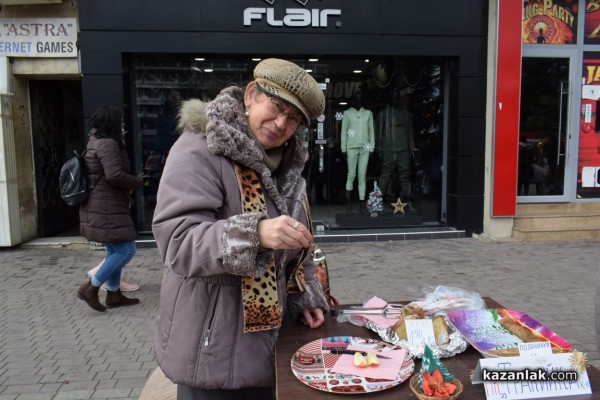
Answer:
[{"xmin": 178, "ymin": 86, "xmax": 308, "ymax": 218}]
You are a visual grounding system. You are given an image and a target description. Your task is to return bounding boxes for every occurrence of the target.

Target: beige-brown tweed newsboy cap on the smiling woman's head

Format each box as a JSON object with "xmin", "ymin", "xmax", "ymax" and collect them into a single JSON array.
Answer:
[{"xmin": 254, "ymin": 58, "xmax": 325, "ymax": 121}]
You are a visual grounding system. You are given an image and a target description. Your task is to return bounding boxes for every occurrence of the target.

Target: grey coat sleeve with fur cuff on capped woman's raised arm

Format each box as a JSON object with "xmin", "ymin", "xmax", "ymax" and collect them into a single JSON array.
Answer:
[{"xmin": 152, "ymin": 134, "xmax": 271, "ymax": 277}]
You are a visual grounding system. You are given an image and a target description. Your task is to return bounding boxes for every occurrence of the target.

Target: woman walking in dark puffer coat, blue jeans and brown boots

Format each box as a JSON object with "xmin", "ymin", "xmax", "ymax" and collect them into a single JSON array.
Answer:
[{"xmin": 77, "ymin": 105, "xmax": 143, "ymax": 312}]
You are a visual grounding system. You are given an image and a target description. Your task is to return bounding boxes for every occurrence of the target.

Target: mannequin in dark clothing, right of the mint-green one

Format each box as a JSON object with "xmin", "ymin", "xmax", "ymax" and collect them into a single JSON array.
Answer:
[{"xmin": 377, "ymin": 89, "xmax": 415, "ymax": 200}]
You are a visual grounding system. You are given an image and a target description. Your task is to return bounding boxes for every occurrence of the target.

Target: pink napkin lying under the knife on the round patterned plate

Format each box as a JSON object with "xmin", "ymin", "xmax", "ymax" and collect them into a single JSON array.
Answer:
[{"xmin": 331, "ymin": 346, "xmax": 406, "ymax": 381}]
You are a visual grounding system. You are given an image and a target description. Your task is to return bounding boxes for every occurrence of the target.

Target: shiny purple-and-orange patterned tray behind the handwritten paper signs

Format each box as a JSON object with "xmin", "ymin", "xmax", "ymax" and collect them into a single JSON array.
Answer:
[{"xmin": 447, "ymin": 308, "xmax": 571, "ymax": 357}]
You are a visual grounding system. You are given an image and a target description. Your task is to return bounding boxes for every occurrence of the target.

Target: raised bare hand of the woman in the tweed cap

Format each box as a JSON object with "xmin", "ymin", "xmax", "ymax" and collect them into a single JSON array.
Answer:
[{"xmin": 258, "ymin": 215, "xmax": 313, "ymax": 250}]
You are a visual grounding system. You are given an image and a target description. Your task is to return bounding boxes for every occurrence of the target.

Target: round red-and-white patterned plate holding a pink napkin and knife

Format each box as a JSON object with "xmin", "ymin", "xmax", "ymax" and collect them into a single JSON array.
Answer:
[{"xmin": 292, "ymin": 336, "xmax": 415, "ymax": 394}]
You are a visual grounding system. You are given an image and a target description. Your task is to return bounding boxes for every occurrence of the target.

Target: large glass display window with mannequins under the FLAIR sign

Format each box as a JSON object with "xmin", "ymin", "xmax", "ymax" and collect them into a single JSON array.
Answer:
[{"xmin": 131, "ymin": 57, "xmax": 444, "ymax": 232}]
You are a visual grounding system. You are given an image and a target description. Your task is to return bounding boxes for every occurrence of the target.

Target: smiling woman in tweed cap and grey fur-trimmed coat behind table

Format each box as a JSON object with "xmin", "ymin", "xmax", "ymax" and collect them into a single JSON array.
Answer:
[{"xmin": 153, "ymin": 59, "xmax": 328, "ymax": 400}]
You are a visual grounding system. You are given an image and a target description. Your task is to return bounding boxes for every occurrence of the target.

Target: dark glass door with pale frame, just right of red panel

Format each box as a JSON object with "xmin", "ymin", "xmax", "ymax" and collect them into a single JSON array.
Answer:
[{"xmin": 517, "ymin": 51, "xmax": 577, "ymax": 203}]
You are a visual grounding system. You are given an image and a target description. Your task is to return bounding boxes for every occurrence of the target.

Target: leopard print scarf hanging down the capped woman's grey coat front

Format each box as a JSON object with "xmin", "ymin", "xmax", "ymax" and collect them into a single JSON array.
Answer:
[{"xmin": 234, "ymin": 163, "xmax": 308, "ymax": 333}]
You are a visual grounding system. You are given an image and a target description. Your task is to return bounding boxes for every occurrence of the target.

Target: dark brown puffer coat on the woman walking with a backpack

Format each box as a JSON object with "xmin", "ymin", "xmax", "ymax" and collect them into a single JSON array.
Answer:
[{"xmin": 79, "ymin": 136, "xmax": 143, "ymax": 243}]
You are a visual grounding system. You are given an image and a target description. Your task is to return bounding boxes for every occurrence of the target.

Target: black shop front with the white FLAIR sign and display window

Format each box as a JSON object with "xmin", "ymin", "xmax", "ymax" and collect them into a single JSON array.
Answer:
[{"xmin": 80, "ymin": 0, "xmax": 488, "ymax": 238}]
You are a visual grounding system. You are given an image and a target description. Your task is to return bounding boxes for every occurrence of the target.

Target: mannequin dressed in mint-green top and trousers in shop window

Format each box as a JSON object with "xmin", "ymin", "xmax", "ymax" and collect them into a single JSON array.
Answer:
[{"xmin": 341, "ymin": 93, "xmax": 375, "ymax": 212}]
